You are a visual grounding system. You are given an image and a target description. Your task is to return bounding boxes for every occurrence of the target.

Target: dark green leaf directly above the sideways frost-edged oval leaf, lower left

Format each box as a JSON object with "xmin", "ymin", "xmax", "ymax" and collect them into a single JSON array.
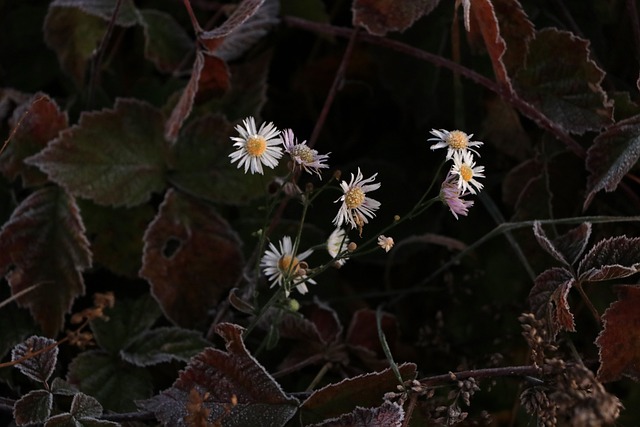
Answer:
[{"xmin": 91, "ymin": 294, "xmax": 161, "ymax": 356}]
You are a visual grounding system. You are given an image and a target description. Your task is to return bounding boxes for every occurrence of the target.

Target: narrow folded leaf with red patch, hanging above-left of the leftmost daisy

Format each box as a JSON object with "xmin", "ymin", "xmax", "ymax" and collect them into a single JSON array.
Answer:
[{"xmin": 164, "ymin": 51, "xmax": 229, "ymax": 142}]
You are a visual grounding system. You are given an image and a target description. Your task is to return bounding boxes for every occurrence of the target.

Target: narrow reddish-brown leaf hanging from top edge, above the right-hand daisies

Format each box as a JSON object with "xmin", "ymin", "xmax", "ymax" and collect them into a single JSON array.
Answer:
[{"xmin": 471, "ymin": 0, "xmax": 513, "ymax": 92}]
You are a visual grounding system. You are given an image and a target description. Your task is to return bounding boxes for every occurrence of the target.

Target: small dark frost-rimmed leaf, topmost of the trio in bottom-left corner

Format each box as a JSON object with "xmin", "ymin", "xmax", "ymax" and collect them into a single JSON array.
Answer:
[{"xmin": 11, "ymin": 336, "xmax": 58, "ymax": 383}]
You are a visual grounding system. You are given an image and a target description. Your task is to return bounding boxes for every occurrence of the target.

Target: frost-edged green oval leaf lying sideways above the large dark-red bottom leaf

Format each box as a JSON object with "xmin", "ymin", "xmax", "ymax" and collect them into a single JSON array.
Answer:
[{"xmin": 120, "ymin": 327, "xmax": 211, "ymax": 366}]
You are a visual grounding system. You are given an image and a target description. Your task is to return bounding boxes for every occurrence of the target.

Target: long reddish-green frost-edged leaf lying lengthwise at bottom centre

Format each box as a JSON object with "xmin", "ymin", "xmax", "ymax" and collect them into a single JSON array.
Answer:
[{"xmin": 300, "ymin": 363, "xmax": 416, "ymax": 425}]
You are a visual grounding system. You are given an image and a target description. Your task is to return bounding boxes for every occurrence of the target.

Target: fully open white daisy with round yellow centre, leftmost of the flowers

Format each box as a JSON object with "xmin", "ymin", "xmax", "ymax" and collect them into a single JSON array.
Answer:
[{"xmin": 229, "ymin": 117, "xmax": 282, "ymax": 174}]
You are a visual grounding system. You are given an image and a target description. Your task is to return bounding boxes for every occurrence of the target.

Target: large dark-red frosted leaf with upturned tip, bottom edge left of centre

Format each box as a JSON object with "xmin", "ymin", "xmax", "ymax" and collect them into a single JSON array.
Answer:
[{"xmin": 140, "ymin": 323, "xmax": 298, "ymax": 427}]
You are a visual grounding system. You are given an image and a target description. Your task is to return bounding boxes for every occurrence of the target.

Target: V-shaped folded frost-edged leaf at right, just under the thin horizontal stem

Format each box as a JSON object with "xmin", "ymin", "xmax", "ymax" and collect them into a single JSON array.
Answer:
[{"xmin": 533, "ymin": 221, "xmax": 591, "ymax": 267}]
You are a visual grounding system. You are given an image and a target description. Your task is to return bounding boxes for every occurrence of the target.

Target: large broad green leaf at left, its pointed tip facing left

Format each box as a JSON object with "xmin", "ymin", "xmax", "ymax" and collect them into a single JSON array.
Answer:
[{"xmin": 26, "ymin": 99, "xmax": 167, "ymax": 206}]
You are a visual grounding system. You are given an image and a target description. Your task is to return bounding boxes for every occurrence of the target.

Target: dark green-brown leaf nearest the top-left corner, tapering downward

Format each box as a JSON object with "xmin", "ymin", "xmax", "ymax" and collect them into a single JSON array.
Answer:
[{"xmin": 44, "ymin": 7, "xmax": 107, "ymax": 87}]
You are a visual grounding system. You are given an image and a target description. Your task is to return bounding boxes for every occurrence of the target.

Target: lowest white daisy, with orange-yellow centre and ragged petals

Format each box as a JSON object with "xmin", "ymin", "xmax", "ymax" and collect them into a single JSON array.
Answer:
[{"xmin": 260, "ymin": 236, "xmax": 316, "ymax": 296}]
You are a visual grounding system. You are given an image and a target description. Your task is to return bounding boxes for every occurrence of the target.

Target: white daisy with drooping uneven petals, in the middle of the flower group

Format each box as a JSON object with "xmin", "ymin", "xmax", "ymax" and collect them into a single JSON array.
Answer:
[{"xmin": 333, "ymin": 168, "xmax": 380, "ymax": 232}]
